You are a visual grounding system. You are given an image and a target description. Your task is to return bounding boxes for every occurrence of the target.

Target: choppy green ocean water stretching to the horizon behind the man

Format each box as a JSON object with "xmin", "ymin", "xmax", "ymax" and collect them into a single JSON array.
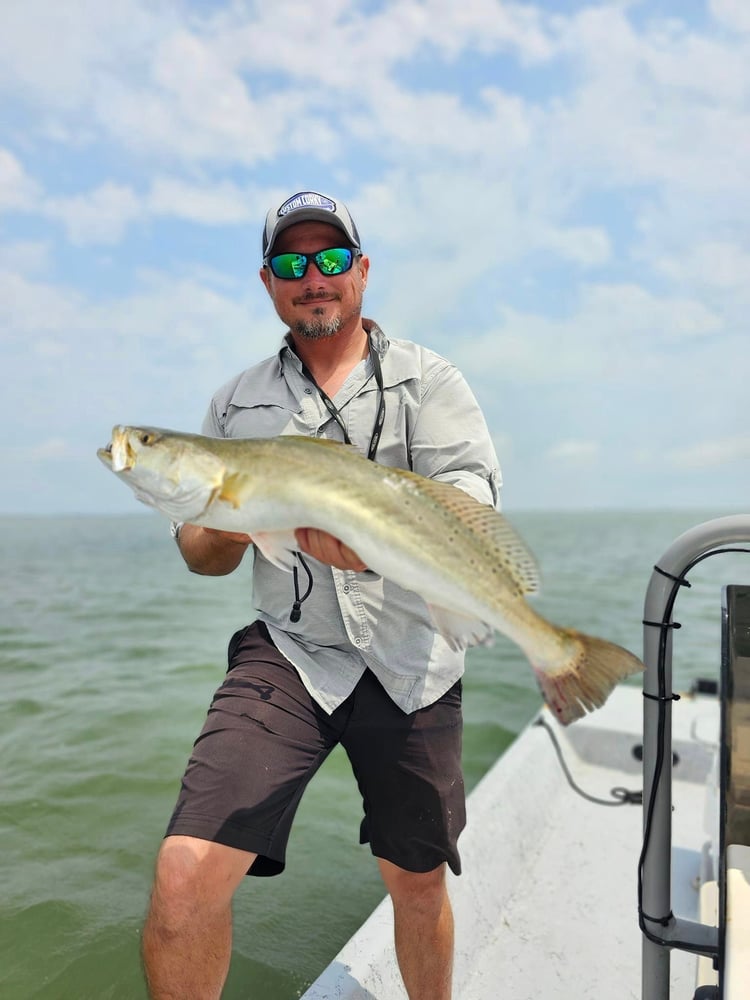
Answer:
[{"xmin": 0, "ymin": 511, "xmax": 750, "ymax": 1000}]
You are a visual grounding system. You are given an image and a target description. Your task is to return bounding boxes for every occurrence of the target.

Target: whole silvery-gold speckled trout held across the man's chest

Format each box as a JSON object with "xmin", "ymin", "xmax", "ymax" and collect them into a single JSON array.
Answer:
[{"xmin": 98, "ymin": 426, "xmax": 643, "ymax": 725}]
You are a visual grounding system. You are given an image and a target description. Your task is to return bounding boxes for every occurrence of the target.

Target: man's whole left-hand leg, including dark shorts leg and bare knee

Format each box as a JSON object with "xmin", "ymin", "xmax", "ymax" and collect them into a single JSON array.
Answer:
[{"xmin": 143, "ymin": 622, "xmax": 346, "ymax": 1000}]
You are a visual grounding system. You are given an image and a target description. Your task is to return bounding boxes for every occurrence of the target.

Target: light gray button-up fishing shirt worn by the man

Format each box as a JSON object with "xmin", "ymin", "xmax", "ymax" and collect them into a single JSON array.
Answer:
[{"xmin": 203, "ymin": 320, "xmax": 500, "ymax": 713}]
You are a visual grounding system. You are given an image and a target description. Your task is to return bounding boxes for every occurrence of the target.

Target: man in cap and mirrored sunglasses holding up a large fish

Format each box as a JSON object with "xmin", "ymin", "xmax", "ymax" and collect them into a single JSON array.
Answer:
[{"xmin": 143, "ymin": 191, "xmax": 498, "ymax": 1000}]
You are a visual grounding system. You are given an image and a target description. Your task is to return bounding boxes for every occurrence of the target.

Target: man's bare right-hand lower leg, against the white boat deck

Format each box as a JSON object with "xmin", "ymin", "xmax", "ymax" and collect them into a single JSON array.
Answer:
[{"xmin": 378, "ymin": 858, "xmax": 453, "ymax": 1000}]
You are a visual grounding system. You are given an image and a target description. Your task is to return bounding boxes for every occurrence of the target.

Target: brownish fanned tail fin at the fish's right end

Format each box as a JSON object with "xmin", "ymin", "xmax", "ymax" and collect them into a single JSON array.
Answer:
[{"xmin": 532, "ymin": 629, "xmax": 643, "ymax": 726}]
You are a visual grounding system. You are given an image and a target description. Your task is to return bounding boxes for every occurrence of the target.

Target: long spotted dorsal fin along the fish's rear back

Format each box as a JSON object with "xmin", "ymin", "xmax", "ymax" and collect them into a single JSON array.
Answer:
[{"xmin": 390, "ymin": 469, "xmax": 539, "ymax": 594}]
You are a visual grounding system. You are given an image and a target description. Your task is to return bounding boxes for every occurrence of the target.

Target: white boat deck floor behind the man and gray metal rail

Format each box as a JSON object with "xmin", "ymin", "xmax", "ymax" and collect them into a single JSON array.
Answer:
[{"xmin": 303, "ymin": 686, "xmax": 719, "ymax": 1000}]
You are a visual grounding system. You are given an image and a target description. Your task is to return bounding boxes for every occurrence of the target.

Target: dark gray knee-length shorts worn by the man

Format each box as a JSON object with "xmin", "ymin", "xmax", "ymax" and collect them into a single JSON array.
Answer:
[{"xmin": 167, "ymin": 622, "xmax": 466, "ymax": 875}]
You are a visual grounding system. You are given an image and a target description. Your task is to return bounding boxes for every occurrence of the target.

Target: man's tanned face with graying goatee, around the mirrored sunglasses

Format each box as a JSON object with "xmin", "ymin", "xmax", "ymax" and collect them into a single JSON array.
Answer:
[{"xmin": 260, "ymin": 222, "xmax": 370, "ymax": 340}]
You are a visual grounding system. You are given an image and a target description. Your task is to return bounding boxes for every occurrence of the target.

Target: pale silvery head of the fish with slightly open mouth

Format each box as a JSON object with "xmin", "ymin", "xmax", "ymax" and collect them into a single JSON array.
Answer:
[{"xmin": 97, "ymin": 424, "xmax": 225, "ymax": 521}]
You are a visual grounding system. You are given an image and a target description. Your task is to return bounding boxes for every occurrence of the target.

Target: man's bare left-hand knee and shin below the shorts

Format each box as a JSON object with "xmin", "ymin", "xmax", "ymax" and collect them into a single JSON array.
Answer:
[{"xmin": 143, "ymin": 836, "xmax": 256, "ymax": 1000}]
